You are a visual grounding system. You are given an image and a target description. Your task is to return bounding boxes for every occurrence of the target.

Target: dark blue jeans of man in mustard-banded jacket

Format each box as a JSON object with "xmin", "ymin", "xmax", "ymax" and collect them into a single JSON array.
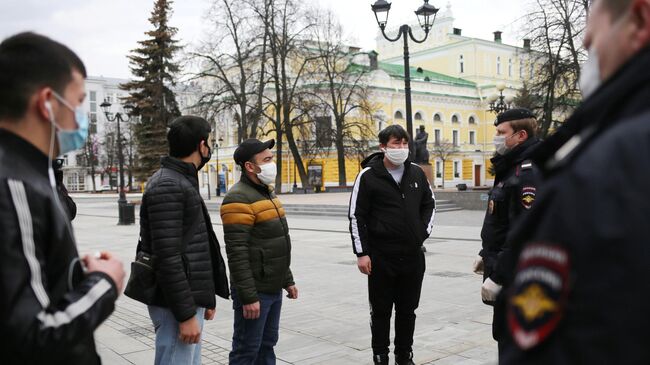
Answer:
[{"xmin": 229, "ymin": 286, "xmax": 282, "ymax": 365}]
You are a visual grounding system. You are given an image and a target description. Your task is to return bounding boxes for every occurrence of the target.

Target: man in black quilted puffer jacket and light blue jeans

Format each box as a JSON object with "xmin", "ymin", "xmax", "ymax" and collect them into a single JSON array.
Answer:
[{"xmin": 140, "ymin": 116, "xmax": 229, "ymax": 365}]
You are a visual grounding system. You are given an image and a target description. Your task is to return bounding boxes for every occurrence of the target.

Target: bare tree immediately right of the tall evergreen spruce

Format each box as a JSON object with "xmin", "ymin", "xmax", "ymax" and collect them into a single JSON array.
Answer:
[{"xmin": 190, "ymin": 0, "xmax": 269, "ymax": 143}]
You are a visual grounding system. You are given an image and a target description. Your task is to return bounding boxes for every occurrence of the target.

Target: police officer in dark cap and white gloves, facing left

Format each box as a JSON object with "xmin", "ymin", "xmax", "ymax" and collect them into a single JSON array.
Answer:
[{"xmin": 474, "ymin": 109, "xmax": 540, "ymax": 350}]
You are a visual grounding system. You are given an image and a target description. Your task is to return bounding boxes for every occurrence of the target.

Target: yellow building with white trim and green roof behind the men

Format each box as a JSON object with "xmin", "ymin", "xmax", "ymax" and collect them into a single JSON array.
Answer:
[{"xmin": 203, "ymin": 5, "xmax": 533, "ymax": 191}]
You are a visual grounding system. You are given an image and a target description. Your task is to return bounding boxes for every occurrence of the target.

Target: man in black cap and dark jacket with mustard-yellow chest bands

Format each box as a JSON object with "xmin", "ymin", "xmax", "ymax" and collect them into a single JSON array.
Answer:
[{"xmin": 221, "ymin": 139, "xmax": 298, "ymax": 365}]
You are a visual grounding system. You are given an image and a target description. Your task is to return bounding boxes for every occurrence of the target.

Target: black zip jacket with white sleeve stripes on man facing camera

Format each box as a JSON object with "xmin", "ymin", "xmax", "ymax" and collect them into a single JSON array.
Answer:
[{"xmin": 349, "ymin": 152, "xmax": 436, "ymax": 257}]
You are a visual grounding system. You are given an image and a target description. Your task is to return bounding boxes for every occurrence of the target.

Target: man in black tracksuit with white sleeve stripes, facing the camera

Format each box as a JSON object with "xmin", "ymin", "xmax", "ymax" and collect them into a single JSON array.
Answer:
[{"xmin": 349, "ymin": 125, "xmax": 435, "ymax": 365}]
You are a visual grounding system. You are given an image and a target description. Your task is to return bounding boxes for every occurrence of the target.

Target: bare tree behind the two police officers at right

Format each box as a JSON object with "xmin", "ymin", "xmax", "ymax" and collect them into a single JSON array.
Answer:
[{"xmin": 524, "ymin": 0, "xmax": 589, "ymax": 136}]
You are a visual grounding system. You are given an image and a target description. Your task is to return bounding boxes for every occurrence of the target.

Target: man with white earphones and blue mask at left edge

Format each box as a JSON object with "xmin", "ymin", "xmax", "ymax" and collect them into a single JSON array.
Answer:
[{"xmin": 0, "ymin": 33, "xmax": 124, "ymax": 364}]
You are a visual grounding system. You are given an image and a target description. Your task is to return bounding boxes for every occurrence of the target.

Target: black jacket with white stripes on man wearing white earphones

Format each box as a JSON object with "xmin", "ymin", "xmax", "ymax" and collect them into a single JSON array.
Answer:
[{"xmin": 0, "ymin": 129, "xmax": 117, "ymax": 364}]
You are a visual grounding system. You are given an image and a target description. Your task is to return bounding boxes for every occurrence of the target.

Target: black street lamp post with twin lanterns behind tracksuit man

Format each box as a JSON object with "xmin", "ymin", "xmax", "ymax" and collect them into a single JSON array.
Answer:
[{"xmin": 371, "ymin": 0, "xmax": 439, "ymax": 155}]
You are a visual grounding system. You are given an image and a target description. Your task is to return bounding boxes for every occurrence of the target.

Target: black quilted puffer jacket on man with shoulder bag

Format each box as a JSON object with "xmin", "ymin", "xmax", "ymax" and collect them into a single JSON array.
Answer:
[{"xmin": 140, "ymin": 157, "xmax": 228, "ymax": 322}]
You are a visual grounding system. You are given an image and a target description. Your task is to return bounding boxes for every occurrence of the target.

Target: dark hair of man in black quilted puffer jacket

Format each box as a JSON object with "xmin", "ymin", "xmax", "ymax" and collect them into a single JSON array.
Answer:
[{"xmin": 167, "ymin": 115, "xmax": 210, "ymax": 158}]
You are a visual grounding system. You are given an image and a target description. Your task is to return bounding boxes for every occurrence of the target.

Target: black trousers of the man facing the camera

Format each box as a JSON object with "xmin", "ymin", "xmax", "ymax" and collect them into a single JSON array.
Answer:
[{"xmin": 368, "ymin": 252, "xmax": 426, "ymax": 355}]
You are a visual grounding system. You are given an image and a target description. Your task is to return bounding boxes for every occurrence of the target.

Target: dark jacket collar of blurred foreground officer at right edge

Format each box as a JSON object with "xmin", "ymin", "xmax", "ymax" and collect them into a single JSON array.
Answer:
[{"xmin": 533, "ymin": 46, "xmax": 650, "ymax": 174}]
